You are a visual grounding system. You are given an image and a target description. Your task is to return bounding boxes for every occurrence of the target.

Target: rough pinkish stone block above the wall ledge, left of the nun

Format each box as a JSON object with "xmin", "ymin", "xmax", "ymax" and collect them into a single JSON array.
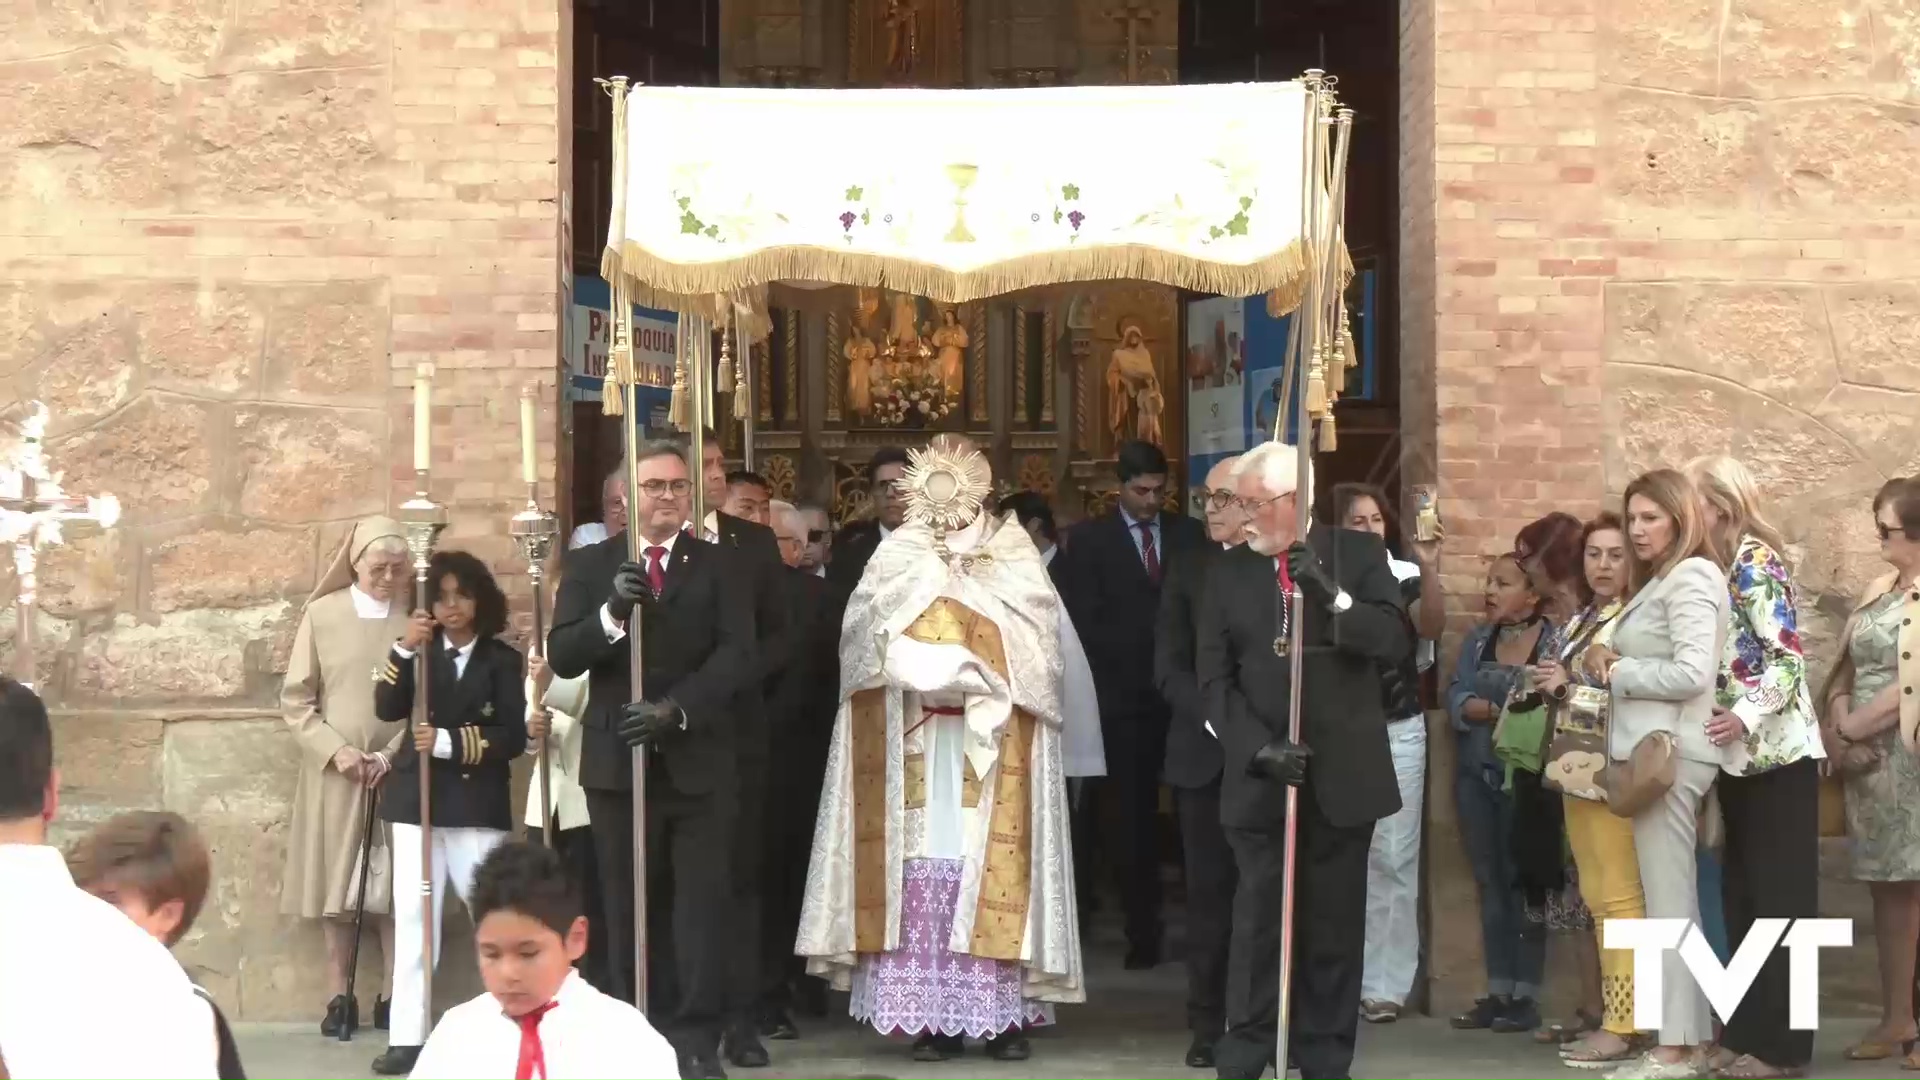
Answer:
[{"xmin": 75, "ymin": 603, "xmax": 286, "ymax": 703}]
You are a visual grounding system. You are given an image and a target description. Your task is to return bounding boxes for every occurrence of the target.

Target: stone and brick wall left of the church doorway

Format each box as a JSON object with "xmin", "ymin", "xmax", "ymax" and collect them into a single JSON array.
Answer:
[{"xmin": 0, "ymin": 0, "xmax": 563, "ymax": 1020}]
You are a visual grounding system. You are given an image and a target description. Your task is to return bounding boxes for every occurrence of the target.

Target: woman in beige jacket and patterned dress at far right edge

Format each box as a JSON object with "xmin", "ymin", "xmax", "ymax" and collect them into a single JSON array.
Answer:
[{"xmin": 1820, "ymin": 477, "xmax": 1920, "ymax": 1068}]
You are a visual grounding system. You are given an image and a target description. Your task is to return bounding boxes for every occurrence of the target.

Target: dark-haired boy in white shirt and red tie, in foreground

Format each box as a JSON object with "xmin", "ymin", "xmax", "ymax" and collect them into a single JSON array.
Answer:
[{"xmin": 413, "ymin": 842, "xmax": 680, "ymax": 1080}]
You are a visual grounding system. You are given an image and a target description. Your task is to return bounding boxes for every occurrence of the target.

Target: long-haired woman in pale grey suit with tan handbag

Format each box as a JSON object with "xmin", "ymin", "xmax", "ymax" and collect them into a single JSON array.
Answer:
[{"xmin": 1586, "ymin": 469, "xmax": 1730, "ymax": 1080}]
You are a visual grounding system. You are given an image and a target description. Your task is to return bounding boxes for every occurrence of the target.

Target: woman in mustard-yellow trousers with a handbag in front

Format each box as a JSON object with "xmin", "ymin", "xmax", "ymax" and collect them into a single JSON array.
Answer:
[{"xmin": 1536, "ymin": 513, "xmax": 1647, "ymax": 1068}]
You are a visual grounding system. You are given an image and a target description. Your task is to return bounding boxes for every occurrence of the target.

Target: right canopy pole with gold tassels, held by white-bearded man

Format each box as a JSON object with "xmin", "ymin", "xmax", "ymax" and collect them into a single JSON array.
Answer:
[{"xmin": 1273, "ymin": 69, "xmax": 1354, "ymax": 1078}]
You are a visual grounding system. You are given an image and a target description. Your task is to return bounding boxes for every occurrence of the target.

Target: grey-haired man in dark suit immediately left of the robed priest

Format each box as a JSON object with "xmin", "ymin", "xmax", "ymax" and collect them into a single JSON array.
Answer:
[{"xmin": 758, "ymin": 502, "xmax": 839, "ymax": 1040}]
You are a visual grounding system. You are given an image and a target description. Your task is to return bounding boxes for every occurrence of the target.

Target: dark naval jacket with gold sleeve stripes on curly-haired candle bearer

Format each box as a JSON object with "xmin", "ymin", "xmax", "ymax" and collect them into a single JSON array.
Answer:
[{"xmin": 372, "ymin": 630, "xmax": 526, "ymax": 832}]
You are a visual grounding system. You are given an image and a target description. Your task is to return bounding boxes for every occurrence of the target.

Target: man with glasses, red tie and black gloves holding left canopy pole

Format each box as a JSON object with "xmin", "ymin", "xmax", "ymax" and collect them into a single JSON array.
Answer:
[{"xmin": 547, "ymin": 442, "xmax": 758, "ymax": 1080}]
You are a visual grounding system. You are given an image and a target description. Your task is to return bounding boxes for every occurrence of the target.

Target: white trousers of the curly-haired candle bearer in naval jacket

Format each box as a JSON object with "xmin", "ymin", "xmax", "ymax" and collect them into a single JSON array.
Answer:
[{"xmin": 386, "ymin": 824, "xmax": 507, "ymax": 1045}]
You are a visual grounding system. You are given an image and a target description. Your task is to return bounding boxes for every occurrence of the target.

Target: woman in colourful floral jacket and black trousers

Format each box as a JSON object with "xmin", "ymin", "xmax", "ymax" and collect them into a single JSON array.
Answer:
[{"xmin": 1688, "ymin": 457, "xmax": 1826, "ymax": 1080}]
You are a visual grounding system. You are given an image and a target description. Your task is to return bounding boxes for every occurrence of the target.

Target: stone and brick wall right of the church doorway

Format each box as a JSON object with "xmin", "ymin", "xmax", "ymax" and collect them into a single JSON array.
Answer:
[{"xmin": 1404, "ymin": 0, "xmax": 1920, "ymax": 1007}]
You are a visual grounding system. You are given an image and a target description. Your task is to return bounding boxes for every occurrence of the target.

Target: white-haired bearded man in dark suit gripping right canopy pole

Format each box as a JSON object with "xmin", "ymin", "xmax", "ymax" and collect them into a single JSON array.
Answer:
[{"xmin": 1194, "ymin": 442, "xmax": 1413, "ymax": 1080}]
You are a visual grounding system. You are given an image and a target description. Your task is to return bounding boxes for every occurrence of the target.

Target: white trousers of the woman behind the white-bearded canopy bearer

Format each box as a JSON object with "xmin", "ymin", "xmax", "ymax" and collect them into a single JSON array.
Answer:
[{"xmin": 1359, "ymin": 717, "xmax": 1427, "ymax": 1005}]
